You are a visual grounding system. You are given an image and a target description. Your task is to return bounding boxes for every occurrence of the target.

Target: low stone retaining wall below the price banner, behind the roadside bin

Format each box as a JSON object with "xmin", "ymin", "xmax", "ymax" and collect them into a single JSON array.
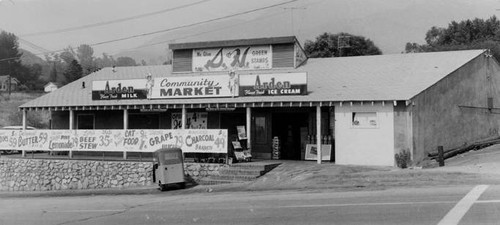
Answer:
[{"xmin": 0, "ymin": 158, "xmax": 227, "ymax": 191}]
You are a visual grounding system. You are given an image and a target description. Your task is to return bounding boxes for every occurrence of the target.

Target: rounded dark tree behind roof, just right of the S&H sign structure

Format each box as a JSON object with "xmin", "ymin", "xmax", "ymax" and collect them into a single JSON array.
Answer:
[{"xmin": 304, "ymin": 32, "xmax": 382, "ymax": 58}]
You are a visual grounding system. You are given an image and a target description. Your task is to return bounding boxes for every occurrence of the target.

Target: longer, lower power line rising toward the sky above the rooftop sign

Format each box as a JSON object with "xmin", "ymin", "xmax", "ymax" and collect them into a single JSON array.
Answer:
[{"xmin": 0, "ymin": 0, "xmax": 299, "ymax": 62}]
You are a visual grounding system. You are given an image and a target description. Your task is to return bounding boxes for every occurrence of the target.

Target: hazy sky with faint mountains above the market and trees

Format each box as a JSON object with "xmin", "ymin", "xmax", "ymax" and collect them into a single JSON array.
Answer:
[{"xmin": 0, "ymin": 0, "xmax": 500, "ymax": 63}]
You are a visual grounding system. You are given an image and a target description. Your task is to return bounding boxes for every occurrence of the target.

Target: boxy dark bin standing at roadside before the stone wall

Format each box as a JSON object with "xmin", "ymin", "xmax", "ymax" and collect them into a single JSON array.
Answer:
[{"xmin": 153, "ymin": 148, "xmax": 186, "ymax": 191}]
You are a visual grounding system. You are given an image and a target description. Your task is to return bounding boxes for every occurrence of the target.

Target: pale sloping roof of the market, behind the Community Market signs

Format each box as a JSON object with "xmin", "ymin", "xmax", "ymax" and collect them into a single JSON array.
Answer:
[{"xmin": 20, "ymin": 50, "xmax": 484, "ymax": 108}]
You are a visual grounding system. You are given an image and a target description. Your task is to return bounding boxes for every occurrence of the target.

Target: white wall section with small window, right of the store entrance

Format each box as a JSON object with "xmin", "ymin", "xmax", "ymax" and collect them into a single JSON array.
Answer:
[{"xmin": 335, "ymin": 102, "xmax": 394, "ymax": 166}]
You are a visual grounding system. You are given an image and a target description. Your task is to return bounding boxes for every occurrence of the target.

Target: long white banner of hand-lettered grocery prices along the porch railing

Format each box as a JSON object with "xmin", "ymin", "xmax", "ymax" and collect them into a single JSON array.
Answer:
[{"xmin": 0, "ymin": 129, "xmax": 228, "ymax": 153}]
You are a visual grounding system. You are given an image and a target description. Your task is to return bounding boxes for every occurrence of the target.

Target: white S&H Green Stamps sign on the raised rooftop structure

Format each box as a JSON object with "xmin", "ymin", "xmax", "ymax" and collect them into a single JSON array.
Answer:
[{"xmin": 192, "ymin": 45, "xmax": 273, "ymax": 72}]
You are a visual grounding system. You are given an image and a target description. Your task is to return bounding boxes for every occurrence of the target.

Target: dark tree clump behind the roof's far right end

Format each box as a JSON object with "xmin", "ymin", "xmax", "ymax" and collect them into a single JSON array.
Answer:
[{"xmin": 405, "ymin": 16, "xmax": 500, "ymax": 60}]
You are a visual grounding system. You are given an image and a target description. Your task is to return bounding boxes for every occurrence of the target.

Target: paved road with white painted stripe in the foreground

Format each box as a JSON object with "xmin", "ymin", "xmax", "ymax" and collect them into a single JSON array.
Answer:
[{"xmin": 0, "ymin": 185, "xmax": 500, "ymax": 225}]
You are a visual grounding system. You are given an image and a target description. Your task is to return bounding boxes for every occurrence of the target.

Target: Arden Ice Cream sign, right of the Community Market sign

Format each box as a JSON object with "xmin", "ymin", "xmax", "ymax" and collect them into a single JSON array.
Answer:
[{"xmin": 239, "ymin": 73, "xmax": 307, "ymax": 96}]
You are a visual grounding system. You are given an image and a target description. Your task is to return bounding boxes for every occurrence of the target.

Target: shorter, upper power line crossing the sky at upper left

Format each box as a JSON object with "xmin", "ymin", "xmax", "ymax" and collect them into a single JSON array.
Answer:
[{"xmin": 21, "ymin": 0, "xmax": 212, "ymax": 37}]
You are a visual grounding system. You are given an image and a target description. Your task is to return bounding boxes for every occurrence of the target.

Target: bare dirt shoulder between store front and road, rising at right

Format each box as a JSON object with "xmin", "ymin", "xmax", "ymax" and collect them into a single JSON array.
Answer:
[{"xmin": 208, "ymin": 145, "xmax": 500, "ymax": 191}]
